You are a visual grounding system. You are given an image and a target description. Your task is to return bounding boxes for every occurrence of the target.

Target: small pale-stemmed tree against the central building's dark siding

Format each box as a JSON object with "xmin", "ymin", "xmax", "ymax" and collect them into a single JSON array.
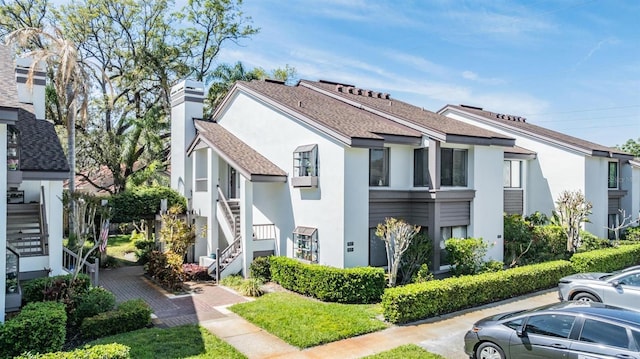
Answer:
[{"xmin": 376, "ymin": 218, "xmax": 420, "ymax": 287}]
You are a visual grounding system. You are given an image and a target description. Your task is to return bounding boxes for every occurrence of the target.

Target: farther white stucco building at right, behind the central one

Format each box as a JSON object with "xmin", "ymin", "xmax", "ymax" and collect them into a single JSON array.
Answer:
[{"xmin": 438, "ymin": 105, "xmax": 640, "ymax": 238}]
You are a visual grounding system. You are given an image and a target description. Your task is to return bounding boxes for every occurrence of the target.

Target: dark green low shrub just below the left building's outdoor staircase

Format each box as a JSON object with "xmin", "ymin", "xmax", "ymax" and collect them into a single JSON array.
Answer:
[{"xmin": 22, "ymin": 274, "xmax": 91, "ymax": 303}]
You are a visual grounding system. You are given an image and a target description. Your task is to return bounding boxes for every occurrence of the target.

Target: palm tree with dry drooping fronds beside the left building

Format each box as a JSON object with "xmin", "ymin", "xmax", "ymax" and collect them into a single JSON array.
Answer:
[{"xmin": 6, "ymin": 27, "xmax": 90, "ymax": 238}]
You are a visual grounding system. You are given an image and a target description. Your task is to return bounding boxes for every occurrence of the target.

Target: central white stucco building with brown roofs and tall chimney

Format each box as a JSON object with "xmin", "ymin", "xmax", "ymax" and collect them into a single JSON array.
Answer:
[{"xmin": 171, "ymin": 80, "xmax": 515, "ymax": 274}]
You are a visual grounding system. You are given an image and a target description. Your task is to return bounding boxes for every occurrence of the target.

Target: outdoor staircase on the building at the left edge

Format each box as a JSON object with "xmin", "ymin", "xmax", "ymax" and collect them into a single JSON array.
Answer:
[{"xmin": 7, "ymin": 203, "xmax": 49, "ymax": 257}]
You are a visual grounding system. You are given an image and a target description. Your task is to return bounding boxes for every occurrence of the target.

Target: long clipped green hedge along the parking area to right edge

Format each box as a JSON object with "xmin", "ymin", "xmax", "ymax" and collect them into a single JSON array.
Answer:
[{"xmin": 382, "ymin": 244, "xmax": 640, "ymax": 323}]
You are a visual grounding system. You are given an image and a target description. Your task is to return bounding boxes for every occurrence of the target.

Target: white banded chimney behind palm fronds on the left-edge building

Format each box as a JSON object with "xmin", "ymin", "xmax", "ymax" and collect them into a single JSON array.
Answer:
[{"xmin": 16, "ymin": 58, "xmax": 47, "ymax": 120}]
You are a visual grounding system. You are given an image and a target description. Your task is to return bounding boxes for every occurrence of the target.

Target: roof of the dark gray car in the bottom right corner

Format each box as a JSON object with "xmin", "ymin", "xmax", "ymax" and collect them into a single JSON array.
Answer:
[{"xmin": 518, "ymin": 301, "xmax": 640, "ymax": 329}]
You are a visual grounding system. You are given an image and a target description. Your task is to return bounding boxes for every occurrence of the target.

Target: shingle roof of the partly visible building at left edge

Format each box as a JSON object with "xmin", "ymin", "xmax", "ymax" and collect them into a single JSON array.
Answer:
[{"xmin": 0, "ymin": 45, "xmax": 69, "ymax": 172}]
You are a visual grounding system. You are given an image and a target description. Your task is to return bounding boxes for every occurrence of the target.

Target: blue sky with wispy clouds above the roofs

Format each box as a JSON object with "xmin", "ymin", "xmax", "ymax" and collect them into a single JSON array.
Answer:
[{"xmin": 212, "ymin": 0, "xmax": 640, "ymax": 146}]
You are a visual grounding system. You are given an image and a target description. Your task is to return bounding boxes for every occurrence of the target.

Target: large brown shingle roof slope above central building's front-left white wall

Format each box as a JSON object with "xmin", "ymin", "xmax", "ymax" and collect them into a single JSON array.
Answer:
[{"xmin": 237, "ymin": 81, "xmax": 422, "ymax": 145}]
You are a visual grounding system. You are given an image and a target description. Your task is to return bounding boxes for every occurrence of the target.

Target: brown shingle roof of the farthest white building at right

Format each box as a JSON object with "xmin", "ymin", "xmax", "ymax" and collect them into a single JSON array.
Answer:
[{"xmin": 445, "ymin": 105, "xmax": 630, "ymax": 155}]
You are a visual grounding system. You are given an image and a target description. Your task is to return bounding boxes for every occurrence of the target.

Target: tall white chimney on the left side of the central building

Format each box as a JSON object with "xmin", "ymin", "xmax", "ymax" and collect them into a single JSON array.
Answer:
[{"xmin": 171, "ymin": 80, "xmax": 204, "ymax": 199}]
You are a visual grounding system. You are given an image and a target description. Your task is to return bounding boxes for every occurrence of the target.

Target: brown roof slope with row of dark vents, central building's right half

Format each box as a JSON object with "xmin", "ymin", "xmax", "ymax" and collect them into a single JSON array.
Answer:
[{"xmin": 301, "ymin": 80, "xmax": 513, "ymax": 144}]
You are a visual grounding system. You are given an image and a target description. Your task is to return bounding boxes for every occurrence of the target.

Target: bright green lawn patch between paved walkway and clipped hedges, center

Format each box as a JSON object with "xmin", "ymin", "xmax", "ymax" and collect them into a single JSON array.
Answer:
[{"xmin": 229, "ymin": 292, "xmax": 387, "ymax": 348}]
